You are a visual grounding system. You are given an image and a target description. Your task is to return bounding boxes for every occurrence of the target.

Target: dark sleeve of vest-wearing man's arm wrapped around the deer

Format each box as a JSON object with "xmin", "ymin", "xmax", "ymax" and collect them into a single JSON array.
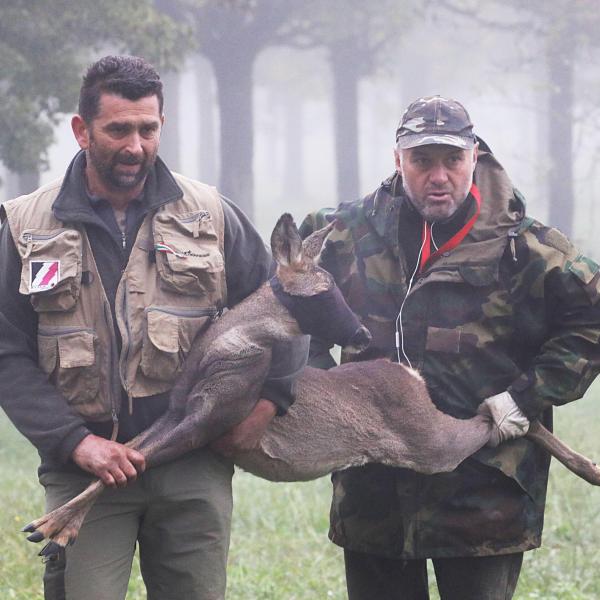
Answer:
[{"xmin": 222, "ymin": 198, "xmax": 309, "ymax": 415}]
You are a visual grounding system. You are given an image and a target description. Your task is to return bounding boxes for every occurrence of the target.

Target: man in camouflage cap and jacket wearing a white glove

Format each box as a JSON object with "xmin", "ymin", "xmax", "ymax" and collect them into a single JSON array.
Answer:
[{"xmin": 301, "ymin": 96, "xmax": 600, "ymax": 600}]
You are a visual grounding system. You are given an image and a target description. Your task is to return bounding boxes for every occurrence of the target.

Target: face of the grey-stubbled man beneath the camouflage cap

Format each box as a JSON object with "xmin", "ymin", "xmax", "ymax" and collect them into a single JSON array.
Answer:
[{"xmin": 395, "ymin": 144, "xmax": 477, "ymax": 221}]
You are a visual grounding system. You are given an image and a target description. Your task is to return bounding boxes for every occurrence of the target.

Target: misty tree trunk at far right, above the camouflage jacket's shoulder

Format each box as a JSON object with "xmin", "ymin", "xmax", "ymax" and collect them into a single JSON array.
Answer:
[{"xmin": 547, "ymin": 24, "xmax": 575, "ymax": 236}]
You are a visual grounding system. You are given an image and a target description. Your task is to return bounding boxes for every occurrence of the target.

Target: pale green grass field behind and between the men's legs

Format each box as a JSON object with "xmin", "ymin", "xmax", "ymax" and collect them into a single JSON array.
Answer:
[{"xmin": 0, "ymin": 382, "xmax": 600, "ymax": 600}]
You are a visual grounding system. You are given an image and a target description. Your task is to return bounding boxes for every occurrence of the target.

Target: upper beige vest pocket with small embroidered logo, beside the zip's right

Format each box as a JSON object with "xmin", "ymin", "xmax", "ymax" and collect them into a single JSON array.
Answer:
[{"xmin": 153, "ymin": 211, "xmax": 224, "ymax": 295}]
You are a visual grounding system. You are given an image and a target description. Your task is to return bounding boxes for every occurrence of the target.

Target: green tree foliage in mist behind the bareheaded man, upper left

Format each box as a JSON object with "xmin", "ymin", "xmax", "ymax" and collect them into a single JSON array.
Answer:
[{"xmin": 0, "ymin": 0, "xmax": 190, "ymax": 171}]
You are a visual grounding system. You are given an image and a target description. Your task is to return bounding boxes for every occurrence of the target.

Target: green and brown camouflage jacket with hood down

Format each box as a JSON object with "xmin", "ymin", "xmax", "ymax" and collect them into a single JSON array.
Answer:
[{"xmin": 301, "ymin": 152, "xmax": 600, "ymax": 558}]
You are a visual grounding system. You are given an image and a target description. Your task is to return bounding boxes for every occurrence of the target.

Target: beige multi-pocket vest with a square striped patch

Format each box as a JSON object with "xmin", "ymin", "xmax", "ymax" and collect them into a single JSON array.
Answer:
[{"xmin": 3, "ymin": 174, "xmax": 227, "ymax": 422}]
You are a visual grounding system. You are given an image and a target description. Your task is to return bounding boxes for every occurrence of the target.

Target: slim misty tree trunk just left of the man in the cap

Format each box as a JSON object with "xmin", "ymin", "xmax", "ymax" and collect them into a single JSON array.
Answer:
[{"xmin": 329, "ymin": 41, "xmax": 360, "ymax": 202}]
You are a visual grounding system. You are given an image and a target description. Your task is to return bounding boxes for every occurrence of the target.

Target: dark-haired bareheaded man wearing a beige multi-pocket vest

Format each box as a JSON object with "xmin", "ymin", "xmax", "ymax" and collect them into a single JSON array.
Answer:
[{"xmin": 0, "ymin": 56, "xmax": 306, "ymax": 600}]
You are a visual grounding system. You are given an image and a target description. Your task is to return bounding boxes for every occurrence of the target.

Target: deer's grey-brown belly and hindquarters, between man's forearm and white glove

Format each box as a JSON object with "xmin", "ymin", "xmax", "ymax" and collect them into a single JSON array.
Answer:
[{"xmin": 234, "ymin": 359, "xmax": 491, "ymax": 481}]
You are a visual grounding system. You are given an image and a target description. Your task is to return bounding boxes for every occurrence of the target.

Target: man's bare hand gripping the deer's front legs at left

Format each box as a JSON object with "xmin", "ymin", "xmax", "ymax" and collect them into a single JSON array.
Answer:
[{"xmin": 71, "ymin": 434, "xmax": 146, "ymax": 487}]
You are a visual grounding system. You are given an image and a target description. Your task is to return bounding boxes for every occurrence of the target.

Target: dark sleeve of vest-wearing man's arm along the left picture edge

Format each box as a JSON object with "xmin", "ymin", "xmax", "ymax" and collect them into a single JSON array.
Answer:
[{"xmin": 0, "ymin": 223, "xmax": 89, "ymax": 463}]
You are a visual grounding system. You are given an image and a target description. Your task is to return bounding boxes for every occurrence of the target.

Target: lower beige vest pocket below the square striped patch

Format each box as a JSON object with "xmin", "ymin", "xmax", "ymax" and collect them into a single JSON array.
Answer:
[{"xmin": 38, "ymin": 327, "xmax": 102, "ymax": 418}]
